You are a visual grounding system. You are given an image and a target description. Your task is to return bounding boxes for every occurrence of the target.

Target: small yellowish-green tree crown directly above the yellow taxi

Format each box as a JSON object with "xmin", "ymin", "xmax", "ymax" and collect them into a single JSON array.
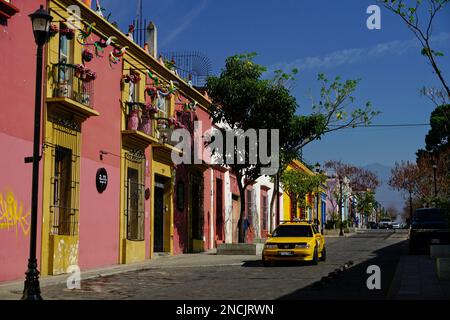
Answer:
[{"xmin": 280, "ymin": 169, "xmax": 326, "ymax": 219}]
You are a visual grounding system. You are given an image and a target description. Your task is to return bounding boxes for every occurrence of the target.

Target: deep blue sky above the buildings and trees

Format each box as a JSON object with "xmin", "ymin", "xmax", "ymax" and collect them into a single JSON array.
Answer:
[{"xmin": 100, "ymin": 0, "xmax": 450, "ymax": 166}]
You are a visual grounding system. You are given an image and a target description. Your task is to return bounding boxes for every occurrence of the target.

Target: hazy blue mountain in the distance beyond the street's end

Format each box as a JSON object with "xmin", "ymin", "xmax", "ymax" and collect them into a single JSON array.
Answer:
[{"xmin": 363, "ymin": 163, "xmax": 405, "ymax": 212}]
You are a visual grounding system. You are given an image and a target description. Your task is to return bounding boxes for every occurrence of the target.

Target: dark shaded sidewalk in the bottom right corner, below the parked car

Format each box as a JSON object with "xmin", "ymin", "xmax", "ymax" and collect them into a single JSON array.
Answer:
[{"xmin": 387, "ymin": 255, "xmax": 450, "ymax": 300}]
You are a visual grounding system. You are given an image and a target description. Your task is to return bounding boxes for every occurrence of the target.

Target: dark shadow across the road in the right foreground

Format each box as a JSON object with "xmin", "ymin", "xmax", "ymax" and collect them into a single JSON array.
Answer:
[{"xmin": 278, "ymin": 241, "xmax": 408, "ymax": 300}]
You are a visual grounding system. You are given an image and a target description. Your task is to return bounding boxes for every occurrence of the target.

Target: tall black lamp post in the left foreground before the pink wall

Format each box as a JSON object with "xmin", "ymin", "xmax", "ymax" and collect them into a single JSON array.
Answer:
[{"xmin": 22, "ymin": 5, "xmax": 53, "ymax": 300}]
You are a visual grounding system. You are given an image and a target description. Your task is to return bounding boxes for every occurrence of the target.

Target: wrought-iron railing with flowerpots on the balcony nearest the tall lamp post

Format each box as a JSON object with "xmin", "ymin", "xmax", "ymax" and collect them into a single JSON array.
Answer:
[{"xmin": 53, "ymin": 63, "xmax": 97, "ymax": 108}]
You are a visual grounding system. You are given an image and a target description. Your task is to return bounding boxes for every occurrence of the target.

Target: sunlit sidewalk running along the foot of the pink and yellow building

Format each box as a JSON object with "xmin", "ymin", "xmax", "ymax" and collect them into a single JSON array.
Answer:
[{"xmin": 0, "ymin": 251, "xmax": 261, "ymax": 300}]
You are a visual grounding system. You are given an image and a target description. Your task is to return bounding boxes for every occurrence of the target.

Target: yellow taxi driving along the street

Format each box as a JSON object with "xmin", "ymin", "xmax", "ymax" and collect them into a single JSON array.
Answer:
[{"xmin": 262, "ymin": 221, "xmax": 327, "ymax": 267}]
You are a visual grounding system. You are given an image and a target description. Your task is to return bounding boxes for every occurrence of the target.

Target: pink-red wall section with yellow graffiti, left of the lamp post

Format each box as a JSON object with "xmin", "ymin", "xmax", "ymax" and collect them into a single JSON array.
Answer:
[{"xmin": 0, "ymin": 0, "xmax": 45, "ymax": 281}]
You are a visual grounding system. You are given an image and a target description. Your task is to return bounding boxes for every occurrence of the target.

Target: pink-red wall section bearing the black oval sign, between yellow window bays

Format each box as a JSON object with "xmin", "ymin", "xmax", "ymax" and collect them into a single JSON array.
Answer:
[{"xmin": 79, "ymin": 31, "xmax": 122, "ymax": 270}]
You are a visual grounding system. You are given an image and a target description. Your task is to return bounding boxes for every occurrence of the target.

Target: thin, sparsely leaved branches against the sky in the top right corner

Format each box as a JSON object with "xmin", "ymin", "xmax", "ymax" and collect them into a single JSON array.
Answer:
[{"xmin": 378, "ymin": 0, "xmax": 450, "ymax": 102}]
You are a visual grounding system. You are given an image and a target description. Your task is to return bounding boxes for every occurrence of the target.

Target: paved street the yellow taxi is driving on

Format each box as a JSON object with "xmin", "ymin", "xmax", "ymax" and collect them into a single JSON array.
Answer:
[{"xmin": 30, "ymin": 230, "xmax": 406, "ymax": 300}]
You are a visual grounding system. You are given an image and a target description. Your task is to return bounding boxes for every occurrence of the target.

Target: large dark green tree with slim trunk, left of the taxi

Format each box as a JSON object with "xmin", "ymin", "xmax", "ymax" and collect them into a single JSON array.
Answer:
[{"xmin": 206, "ymin": 54, "xmax": 297, "ymax": 242}]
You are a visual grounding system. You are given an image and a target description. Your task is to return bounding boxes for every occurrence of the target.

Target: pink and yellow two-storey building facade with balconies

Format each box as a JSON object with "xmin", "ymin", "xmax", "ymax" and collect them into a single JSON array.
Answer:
[{"xmin": 0, "ymin": 0, "xmax": 214, "ymax": 281}]
